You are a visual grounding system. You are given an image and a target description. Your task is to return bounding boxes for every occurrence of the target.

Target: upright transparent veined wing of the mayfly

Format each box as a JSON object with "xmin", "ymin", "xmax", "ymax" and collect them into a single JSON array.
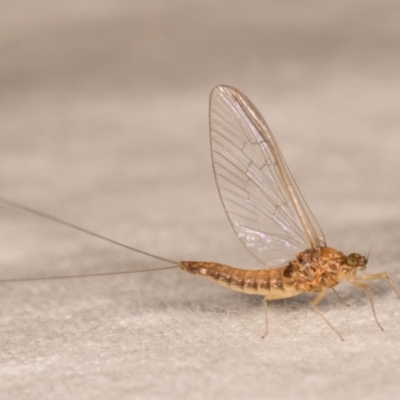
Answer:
[{"xmin": 210, "ymin": 86, "xmax": 325, "ymax": 267}]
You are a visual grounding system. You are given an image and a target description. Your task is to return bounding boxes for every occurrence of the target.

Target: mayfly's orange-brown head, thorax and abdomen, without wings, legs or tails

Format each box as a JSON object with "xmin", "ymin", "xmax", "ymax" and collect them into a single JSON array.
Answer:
[{"xmin": 180, "ymin": 247, "xmax": 366, "ymax": 300}]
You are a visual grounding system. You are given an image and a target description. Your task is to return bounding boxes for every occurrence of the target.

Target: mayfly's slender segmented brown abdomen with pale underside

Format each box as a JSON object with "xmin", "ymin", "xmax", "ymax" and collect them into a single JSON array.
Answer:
[{"xmin": 180, "ymin": 261, "xmax": 298, "ymax": 299}]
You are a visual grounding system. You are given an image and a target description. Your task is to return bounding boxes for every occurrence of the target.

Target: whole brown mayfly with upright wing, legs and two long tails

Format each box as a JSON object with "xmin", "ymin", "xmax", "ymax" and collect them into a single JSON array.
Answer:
[{"xmin": 0, "ymin": 86, "xmax": 400, "ymax": 340}]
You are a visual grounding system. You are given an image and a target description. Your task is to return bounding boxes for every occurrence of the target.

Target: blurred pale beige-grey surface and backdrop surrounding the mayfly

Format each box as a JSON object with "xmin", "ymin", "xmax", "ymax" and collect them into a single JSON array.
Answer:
[{"xmin": 0, "ymin": 0, "xmax": 400, "ymax": 400}]
